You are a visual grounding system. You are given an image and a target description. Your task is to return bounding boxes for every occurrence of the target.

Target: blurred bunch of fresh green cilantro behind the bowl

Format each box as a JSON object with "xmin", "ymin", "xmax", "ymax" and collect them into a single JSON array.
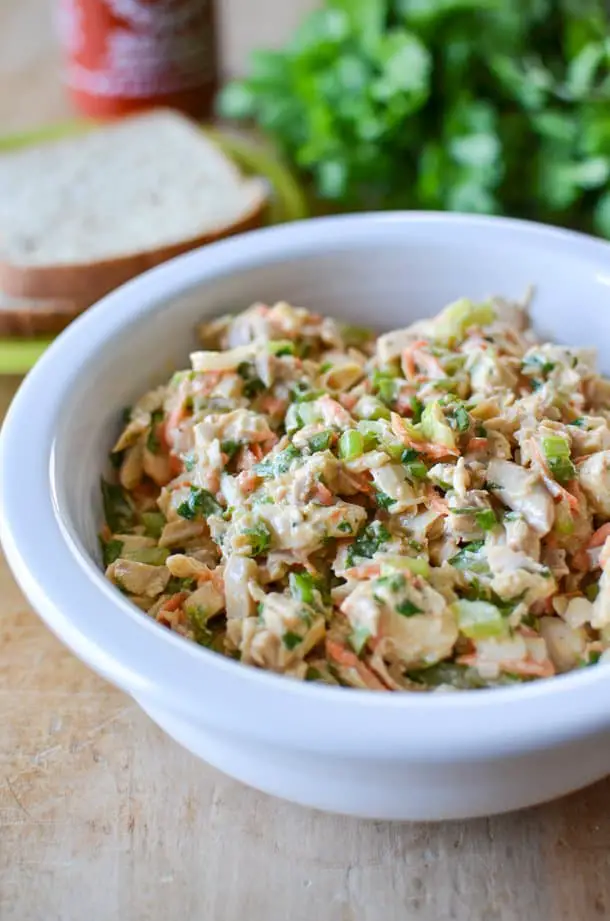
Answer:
[{"xmin": 220, "ymin": 0, "xmax": 610, "ymax": 237}]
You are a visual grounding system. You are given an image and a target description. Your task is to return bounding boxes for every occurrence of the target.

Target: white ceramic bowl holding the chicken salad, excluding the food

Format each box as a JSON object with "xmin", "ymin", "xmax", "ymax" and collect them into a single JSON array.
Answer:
[{"xmin": 0, "ymin": 213, "xmax": 610, "ymax": 819}]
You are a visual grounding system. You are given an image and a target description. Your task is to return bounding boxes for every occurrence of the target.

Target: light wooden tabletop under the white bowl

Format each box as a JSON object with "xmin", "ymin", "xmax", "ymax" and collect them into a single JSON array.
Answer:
[{"xmin": 0, "ymin": 0, "xmax": 610, "ymax": 921}]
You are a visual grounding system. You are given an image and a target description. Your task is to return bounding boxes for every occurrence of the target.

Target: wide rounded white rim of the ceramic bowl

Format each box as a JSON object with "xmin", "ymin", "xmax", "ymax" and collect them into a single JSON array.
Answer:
[{"xmin": 0, "ymin": 212, "xmax": 610, "ymax": 757}]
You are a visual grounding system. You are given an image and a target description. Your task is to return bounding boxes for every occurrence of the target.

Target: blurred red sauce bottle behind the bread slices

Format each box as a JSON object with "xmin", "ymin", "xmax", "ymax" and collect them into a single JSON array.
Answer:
[{"xmin": 59, "ymin": 0, "xmax": 218, "ymax": 118}]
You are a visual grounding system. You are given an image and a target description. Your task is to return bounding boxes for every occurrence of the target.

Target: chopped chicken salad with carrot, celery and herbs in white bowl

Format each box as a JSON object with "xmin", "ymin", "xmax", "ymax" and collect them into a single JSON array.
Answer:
[{"xmin": 101, "ymin": 298, "xmax": 610, "ymax": 691}]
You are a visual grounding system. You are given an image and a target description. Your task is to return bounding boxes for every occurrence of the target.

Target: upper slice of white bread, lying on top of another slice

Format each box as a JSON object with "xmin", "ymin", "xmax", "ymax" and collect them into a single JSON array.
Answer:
[{"xmin": 0, "ymin": 109, "xmax": 267, "ymax": 303}]
